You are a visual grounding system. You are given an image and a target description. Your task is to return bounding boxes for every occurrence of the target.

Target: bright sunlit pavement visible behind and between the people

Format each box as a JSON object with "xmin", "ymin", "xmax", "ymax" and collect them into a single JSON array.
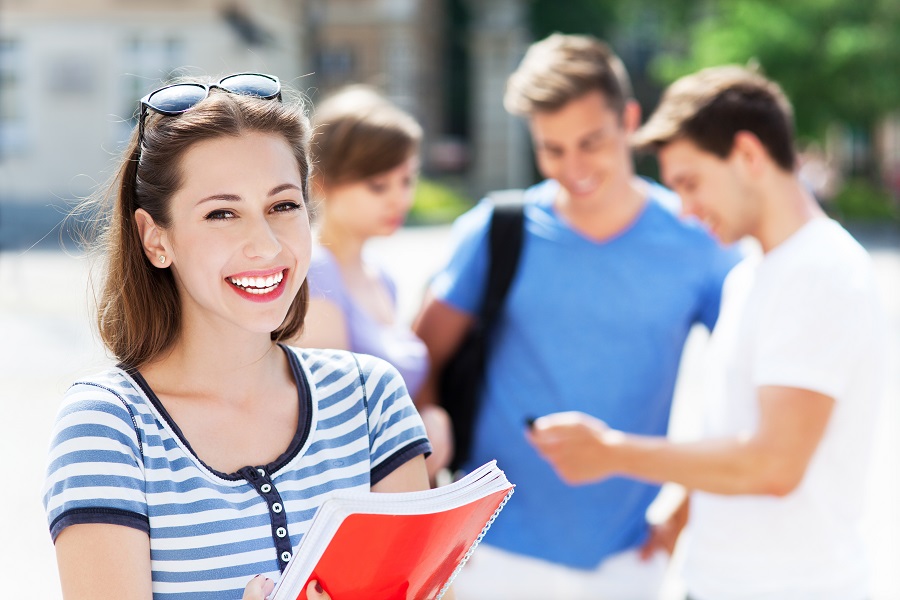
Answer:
[{"xmin": 0, "ymin": 223, "xmax": 900, "ymax": 600}]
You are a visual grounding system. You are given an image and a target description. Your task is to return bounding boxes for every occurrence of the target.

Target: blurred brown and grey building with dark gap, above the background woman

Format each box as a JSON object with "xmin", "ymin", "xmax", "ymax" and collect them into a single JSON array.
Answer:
[{"xmin": 305, "ymin": 0, "xmax": 531, "ymax": 196}]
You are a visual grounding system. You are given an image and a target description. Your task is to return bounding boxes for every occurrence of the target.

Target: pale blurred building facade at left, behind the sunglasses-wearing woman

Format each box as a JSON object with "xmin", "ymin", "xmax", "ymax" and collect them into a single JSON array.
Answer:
[{"xmin": 0, "ymin": 0, "xmax": 304, "ymax": 203}]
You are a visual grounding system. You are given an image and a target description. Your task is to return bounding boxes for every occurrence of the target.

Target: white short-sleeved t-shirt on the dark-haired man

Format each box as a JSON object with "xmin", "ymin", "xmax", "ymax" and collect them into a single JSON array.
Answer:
[{"xmin": 685, "ymin": 218, "xmax": 886, "ymax": 600}]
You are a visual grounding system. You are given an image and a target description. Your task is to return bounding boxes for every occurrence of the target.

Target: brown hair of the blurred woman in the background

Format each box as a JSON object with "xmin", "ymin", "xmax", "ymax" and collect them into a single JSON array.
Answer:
[{"xmin": 311, "ymin": 85, "xmax": 422, "ymax": 189}]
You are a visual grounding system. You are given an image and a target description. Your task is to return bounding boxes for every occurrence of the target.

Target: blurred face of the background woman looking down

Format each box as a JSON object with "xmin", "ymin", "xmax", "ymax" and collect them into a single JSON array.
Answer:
[{"xmin": 325, "ymin": 156, "xmax": 419, "ymax": 239}]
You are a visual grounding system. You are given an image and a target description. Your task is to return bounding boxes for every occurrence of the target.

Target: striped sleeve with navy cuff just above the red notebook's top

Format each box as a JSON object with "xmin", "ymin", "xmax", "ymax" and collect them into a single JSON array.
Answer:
[{"xmin": 357, "ymin": 354, "xmax": 431, "ymax": 484}]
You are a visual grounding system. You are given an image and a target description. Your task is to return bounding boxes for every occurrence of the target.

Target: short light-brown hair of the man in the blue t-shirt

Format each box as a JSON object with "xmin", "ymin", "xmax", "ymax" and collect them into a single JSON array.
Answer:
[{"xmin": 503, "ymin": 33, "xmax": 632, "ymax": 117}]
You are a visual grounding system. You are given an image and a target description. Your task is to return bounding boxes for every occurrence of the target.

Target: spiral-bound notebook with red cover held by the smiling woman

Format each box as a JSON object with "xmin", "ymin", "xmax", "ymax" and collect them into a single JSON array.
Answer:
[{"xmin": 270, "ymin": 461, "xmax": 514, "ymax": 600}]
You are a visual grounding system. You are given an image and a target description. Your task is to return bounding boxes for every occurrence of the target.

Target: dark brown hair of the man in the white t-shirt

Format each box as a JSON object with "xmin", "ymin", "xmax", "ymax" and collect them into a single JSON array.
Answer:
[{"xmin": 631, "ymin": 65, "xmax": 796, "ymax": 171}]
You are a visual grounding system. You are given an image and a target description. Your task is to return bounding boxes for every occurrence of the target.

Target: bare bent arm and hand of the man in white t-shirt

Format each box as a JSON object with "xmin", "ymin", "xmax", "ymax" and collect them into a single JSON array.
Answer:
[{"xmin": 529, "ymin": 386, "xmax": 834, "ymax": 496}]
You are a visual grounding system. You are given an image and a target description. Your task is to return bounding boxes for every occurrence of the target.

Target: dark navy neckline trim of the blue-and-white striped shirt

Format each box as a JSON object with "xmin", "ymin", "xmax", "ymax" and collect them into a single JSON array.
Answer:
[{"xmin": 118, "ymin": 343, "xmax": 313, "ymax": 481}]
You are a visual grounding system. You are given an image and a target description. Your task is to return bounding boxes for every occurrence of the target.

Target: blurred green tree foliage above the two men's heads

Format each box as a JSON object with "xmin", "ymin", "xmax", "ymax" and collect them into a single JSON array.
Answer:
[{"xmin": 530, "ymin": 0, "xmax": 900, "ymax": 138}]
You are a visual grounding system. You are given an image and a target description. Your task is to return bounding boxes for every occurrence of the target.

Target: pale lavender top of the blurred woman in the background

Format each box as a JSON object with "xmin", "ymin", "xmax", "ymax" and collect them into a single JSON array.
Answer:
[{"xmin": 307, "ymin": 244, "xmax": 428, "ymax": 398}]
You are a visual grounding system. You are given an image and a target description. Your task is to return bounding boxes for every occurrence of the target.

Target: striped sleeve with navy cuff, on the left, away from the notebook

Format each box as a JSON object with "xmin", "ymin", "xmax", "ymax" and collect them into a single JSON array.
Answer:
[{"xmin": 43, "ymin": 383, "xmax": 149, "ymax": 541}]
